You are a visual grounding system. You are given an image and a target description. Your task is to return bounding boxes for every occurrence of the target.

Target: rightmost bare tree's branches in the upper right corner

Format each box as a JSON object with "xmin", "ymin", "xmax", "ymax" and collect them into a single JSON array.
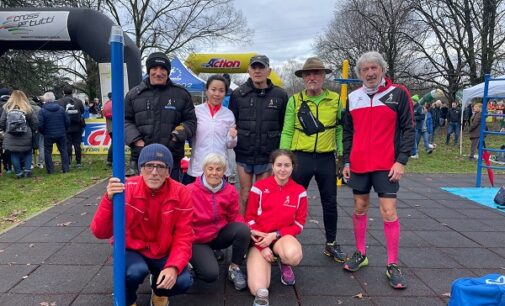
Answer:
[{"xmin": 406, "ymin": 0, "xmax": 505, "ymax": 99}]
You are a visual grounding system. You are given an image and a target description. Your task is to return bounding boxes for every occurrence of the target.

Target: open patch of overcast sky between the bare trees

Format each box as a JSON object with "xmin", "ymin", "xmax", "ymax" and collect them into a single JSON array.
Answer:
[{"xmin": 203, "ymin": 0, "xmax": 336, "ymax": 65}]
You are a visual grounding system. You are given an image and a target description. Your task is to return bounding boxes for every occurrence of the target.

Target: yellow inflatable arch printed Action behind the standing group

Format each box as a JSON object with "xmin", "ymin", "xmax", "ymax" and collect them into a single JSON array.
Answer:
[{"xmin": 184, "ymin": 53, "xmax": 282, "ymax": 87}]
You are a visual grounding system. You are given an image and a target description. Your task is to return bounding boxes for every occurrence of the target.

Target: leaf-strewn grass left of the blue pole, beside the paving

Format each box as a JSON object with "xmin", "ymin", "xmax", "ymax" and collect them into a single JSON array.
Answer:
[{"xmin": 0, "ymin": 155, "xmax": 112, "ymax": 232}]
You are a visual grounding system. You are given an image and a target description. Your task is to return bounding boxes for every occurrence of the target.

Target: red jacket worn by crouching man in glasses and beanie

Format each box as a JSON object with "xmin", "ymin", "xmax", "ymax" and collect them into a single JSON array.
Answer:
[{"xmin": 90, "ymin": 176, "xmax": 194, "ymax": 273}]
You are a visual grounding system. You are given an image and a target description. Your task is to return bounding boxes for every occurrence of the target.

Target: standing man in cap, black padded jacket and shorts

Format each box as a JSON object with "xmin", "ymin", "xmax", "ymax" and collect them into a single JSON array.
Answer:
[{"xmin": 229, "ymin": 55, "xmax": 288, "ymax": 214}]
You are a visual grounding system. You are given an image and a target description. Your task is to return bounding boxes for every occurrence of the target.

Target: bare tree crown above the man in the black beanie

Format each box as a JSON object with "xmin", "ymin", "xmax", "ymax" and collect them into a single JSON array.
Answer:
[{"xmin": 105, "ymin": 0, "xmax": 251, "ymax": 57}]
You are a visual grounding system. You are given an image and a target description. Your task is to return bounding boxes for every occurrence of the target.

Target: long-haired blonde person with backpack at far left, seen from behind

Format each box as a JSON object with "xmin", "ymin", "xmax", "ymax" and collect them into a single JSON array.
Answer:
[{"xmin": 0, "ymin": 90, "xmax": 37, "ymax": 179}]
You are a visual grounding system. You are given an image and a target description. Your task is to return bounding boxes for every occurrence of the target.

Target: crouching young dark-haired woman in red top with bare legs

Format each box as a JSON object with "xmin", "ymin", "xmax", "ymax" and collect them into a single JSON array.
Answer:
[{"xmin": 245, "ymin": 150, "xmax": 307, "ymax": 295}]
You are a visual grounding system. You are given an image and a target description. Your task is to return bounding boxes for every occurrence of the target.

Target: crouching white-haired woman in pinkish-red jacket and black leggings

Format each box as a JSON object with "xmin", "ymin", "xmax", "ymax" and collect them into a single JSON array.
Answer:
[{"xmin": 187, "ymin": 153, "xmax": 251, "ymax": 290}]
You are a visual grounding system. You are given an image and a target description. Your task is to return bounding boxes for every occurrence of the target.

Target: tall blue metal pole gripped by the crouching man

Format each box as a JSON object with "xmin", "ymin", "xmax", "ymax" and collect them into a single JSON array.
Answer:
[{"xmin": 110, "ymin": 26, "xmax": 126, "ymax": 306}]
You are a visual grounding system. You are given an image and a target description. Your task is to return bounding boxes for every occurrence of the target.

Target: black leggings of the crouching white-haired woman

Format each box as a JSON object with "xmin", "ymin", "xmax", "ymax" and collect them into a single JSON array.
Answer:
[{"xmin": 190, "ymin": 222, "xmax": 251, "ymax": 282}]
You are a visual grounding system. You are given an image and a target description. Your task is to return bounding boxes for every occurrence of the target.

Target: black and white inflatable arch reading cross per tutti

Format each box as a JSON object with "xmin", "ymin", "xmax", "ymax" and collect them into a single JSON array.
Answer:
[{"xmin": 0, "ymin": 7, "xmax": 142, "ymax": 89}]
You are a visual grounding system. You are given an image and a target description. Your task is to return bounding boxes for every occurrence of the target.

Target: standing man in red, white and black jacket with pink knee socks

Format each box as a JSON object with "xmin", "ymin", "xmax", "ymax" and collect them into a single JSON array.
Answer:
[{"xmin": 342, "ymin": 52, "xmax": 415, "ymax": 289}]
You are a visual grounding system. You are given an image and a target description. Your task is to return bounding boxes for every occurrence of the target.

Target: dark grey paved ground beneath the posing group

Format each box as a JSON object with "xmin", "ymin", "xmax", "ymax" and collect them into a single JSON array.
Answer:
[{"xmin": 0, "ymin": 175, "xmax": 505, "ymax": 306}]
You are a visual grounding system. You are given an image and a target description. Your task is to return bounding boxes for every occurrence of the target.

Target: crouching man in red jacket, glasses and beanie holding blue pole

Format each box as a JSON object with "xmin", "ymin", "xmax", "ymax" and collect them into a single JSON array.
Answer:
[{"xmin": 90, "ymin": 144, "xmax": 194, "ymax": 306}]
